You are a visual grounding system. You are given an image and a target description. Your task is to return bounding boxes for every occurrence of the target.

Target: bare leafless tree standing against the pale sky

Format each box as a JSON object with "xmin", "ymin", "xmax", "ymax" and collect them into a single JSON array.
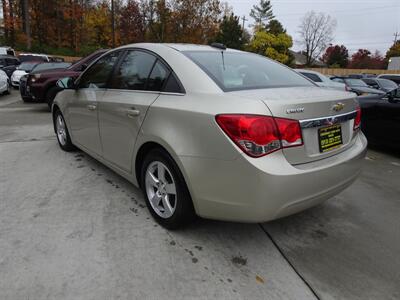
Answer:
[{"xmin": 299, "ymin": 11, "xmax": 336, "ymax": 66}]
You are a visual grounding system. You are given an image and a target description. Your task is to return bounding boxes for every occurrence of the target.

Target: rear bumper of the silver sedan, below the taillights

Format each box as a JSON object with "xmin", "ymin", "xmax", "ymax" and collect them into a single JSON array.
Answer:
[{"xmin": 180, "ymin": 132, "xmax": 367, "ymax": 222}]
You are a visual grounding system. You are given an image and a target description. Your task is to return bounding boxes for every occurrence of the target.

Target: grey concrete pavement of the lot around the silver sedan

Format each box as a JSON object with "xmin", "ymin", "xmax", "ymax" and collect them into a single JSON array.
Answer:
[{"xmin": 0, "ymin": 91, "xmax": 400, "ymax": 299}]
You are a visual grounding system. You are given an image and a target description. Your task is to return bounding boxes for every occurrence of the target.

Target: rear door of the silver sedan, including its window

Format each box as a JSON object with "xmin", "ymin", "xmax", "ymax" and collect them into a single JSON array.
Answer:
[{"xmin": 99, "ymin": 50, "xmax": 170, "ymax": 172}]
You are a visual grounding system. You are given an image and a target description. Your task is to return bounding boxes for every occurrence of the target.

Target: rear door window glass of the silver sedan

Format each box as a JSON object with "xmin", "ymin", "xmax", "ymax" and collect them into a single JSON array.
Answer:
[{"xmin": 112, "ymin": 50, "xmax": 156, "ymax": 90}]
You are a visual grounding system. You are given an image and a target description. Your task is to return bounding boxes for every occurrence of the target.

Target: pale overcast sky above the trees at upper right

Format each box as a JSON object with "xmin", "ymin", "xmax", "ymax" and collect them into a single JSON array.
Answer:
[{"xmin": 226, "ymin": 0, "xmax": 400, "ymax": 55}]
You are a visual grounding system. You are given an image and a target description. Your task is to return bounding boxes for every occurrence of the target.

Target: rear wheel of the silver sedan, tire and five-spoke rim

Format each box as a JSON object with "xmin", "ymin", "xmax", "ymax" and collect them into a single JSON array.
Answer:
[{"xmin": 140, "ymin": 148, "xmax": 195, "ymax": 229}]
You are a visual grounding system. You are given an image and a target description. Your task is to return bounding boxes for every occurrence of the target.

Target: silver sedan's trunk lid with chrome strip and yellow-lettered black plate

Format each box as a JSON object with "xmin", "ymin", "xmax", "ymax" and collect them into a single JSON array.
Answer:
[{"xmin": 232, "ymin": 87, "xmax": 357, "ymax": 165}]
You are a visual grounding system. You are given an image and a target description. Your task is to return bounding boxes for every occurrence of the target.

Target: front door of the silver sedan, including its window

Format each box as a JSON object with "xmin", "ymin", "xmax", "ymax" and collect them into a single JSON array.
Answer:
[{"xmin": 68, "ymin": 51, "xmax": 121, "ymax": 155}]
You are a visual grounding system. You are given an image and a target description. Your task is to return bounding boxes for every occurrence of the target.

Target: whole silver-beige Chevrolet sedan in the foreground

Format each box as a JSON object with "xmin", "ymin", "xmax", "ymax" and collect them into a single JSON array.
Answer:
[{"xmin": 52, "ymin": 44, "xmax": 367, "ymax": 228}]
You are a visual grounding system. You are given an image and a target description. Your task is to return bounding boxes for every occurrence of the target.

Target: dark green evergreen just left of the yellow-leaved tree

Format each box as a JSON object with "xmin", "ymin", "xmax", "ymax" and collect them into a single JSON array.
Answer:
[{"xmin": 215, "ymin": 14, "xmax": 243, "ymax": 49}]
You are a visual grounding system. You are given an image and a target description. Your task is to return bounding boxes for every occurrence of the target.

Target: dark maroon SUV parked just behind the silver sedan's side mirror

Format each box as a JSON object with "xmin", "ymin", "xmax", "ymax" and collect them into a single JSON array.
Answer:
[{"xmin": 20, "ymin": 49, "xmax": 107, "ymax": 106}]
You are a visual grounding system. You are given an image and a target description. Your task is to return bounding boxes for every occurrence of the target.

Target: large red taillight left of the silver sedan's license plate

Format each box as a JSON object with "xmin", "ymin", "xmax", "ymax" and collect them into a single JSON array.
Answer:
[{"xmin": 216, "ymin": 114, "xmax": 303, "ymax": 157}]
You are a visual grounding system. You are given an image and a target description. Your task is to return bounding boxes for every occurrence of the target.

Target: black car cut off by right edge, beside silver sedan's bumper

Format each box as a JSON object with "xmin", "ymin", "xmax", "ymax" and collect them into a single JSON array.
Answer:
[{"xmin": 358, "ymin": 89, "xmax": 400, "ymax": 149}]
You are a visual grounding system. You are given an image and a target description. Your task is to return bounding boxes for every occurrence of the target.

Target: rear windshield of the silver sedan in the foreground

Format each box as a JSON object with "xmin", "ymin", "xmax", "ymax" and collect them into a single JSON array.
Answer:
[{"xmin": 183, "ymin": 51, "xmax": 314, "ymax": 91}]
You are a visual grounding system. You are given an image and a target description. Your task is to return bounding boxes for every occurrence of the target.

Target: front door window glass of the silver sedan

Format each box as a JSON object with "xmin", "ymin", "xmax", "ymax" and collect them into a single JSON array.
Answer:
[{"xmin": 79, "ymin": 52, "xmax": 120, "ymax": 88}]
